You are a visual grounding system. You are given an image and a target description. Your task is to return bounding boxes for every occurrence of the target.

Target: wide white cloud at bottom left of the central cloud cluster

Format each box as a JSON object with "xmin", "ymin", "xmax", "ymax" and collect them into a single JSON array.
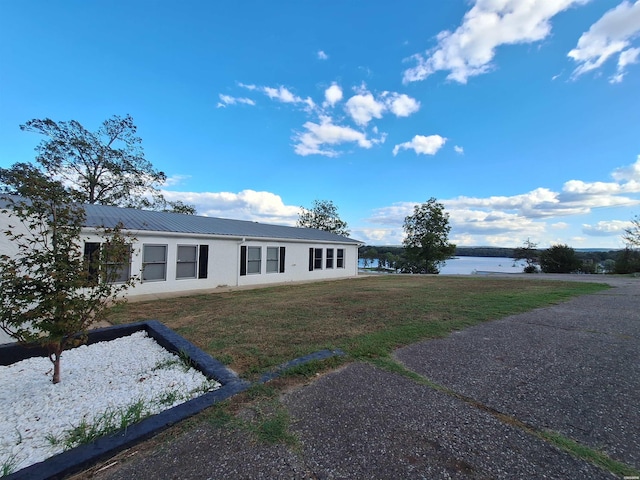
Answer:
[{"xmin": 294, "ymin": 116, "xmax": 384, "ymax": 157}]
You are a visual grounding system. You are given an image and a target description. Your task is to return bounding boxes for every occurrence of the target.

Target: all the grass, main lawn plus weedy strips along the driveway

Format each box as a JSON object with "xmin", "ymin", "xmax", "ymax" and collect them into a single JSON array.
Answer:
[{"xmin": 89, "ymin": 275, "xmax": 635, "ymax": 475}]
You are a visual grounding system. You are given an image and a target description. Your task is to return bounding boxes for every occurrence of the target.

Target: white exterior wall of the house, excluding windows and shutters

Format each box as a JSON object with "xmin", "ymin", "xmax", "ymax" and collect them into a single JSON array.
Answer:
[{"xmin": 0, "ymin": 214, "xmax": 358, "ymax": 297}]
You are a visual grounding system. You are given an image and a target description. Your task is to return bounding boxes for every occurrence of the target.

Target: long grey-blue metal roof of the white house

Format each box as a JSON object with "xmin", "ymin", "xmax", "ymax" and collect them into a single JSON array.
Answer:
[{"xmin": 0, "ymin": 195, "xmax": 362, "ymax": 244}]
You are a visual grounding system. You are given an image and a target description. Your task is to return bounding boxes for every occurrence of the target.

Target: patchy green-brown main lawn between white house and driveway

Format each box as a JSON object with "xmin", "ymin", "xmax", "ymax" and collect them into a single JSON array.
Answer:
[{"xmin": 108, "ymin": 275, "xmax": 607, "ymax": 379}]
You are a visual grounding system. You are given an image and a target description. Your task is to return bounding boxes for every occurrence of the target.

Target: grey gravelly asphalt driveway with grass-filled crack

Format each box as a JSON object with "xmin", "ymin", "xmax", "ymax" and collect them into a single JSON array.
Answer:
[{"xmin": 85, "ymin": 276, "xmax": 640, "ymax": 479}]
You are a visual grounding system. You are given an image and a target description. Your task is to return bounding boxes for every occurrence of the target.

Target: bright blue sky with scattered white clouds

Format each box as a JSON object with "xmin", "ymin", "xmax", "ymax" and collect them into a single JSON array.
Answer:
[{"xmin": 0, "ymin": 0, "xmax": 640, "ymax": 248}]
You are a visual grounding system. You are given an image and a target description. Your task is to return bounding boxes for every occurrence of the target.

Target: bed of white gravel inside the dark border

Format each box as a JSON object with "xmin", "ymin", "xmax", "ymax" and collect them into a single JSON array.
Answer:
[{"xmin": 0, "ymin": 331, "xmax": 220, "ymax": 475}]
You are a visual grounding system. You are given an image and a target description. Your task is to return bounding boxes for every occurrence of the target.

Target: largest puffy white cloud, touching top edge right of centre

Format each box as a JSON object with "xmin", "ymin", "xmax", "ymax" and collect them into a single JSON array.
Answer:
[{"xmin": 403, "ymin": 0, "xmax": 588, "ymax": 83}]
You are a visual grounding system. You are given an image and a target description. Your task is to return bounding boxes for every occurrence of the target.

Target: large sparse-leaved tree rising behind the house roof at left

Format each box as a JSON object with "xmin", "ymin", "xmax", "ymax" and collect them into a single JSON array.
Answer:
[{"xmin": 20, "ymin": 115, "xmax": 195, "ymax": 213}]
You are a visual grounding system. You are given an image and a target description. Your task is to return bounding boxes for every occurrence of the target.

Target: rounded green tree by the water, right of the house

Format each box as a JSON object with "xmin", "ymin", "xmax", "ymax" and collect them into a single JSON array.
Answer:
[{"xmin": 403, "ymin": 197, "xmax": 456, "ymax": 273}]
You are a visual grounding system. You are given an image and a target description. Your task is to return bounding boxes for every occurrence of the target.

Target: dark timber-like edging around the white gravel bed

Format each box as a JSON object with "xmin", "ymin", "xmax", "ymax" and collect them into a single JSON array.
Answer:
[{"xmin": 0, "ymin": 320, "xmax": 250, "ymax": 480}]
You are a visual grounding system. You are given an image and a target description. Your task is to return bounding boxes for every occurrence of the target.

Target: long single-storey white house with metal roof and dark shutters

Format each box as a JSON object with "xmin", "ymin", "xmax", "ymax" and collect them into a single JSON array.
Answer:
[{"xmin": 0, "ymin": 198, "xmax": 362, "ymax": 297}]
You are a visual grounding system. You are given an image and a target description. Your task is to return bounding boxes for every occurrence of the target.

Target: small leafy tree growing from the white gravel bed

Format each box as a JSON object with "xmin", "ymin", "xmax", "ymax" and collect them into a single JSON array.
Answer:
[{"xmin": 0, "ymin": 164, "xmax": 133, "ymax": 383}]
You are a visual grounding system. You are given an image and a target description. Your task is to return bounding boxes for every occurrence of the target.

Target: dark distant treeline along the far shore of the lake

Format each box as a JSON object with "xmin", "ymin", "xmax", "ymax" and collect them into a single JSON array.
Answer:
[{"xmin": 360, "ymin": 245, "xmax": 620, "ymax": 262}]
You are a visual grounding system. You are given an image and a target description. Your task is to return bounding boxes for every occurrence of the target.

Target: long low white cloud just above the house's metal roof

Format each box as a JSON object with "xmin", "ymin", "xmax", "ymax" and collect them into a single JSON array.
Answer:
[{"xmin": 162, "ymin": 190, "xmax": 300, "ymax": 225}]
